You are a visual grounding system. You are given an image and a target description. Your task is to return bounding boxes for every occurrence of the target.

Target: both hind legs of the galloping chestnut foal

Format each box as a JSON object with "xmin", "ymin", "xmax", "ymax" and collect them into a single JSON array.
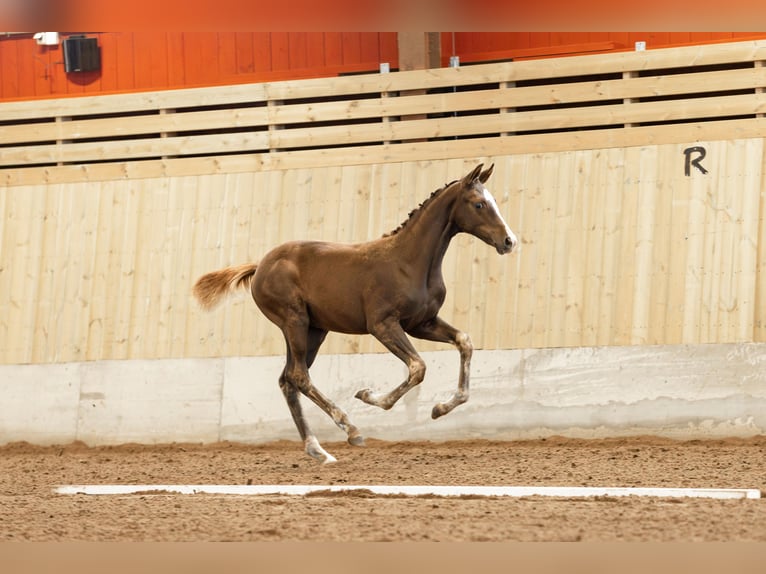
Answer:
[{"xmin": 280, "ymin": 327, "xmax": 364, "ymax": 462}]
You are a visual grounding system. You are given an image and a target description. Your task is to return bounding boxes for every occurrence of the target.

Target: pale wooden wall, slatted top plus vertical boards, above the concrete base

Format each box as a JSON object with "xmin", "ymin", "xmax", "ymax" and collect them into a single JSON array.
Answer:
[{"xmin": 0, "ymin": 42, "xmax": 766, "ymax": 363}]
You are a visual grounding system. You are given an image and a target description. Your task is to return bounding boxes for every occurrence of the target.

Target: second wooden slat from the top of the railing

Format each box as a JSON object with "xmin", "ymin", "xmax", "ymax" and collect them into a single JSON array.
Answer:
[{"xmin": 7, "ymin": 67, "xmax": 766, "ymax": 144}]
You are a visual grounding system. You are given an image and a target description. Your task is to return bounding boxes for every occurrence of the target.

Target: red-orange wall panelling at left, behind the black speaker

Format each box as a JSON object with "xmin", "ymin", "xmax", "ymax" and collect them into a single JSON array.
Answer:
[{"xmin": 0, "ymin": 31, "xmax": 397, "ymax": 100}]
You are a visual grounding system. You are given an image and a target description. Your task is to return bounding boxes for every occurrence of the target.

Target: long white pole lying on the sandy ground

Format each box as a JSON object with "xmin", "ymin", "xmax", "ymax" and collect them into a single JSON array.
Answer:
[{"xmin": 54, "ymin": 484, "xmax": 761, "ymax": 499}]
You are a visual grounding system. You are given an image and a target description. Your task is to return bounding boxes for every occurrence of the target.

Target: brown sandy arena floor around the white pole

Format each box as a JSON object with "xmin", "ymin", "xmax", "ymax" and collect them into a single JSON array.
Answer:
[{"xmin": 0, "ymin": 437, "xmax": 766, "ymax": 542}]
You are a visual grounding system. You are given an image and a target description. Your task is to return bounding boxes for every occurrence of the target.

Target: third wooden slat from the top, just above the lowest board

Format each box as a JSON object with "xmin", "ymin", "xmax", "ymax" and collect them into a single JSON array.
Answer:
[{"xmin": 0, "ymin": 93, "xmax": 766, "ymax": 165}]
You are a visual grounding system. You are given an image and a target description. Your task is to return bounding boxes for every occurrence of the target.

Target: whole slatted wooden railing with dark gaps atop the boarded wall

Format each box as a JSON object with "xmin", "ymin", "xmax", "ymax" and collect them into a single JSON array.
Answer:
[{"xmin": 0, "ymin": 41, "xmax": 766, "ymax": 185}]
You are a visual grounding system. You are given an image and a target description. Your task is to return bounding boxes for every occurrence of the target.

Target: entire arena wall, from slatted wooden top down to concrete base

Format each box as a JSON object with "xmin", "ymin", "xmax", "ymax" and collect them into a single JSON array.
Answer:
[{"xmin": 0, "ymin": 42, "xmax": 766, "ymax": 444}]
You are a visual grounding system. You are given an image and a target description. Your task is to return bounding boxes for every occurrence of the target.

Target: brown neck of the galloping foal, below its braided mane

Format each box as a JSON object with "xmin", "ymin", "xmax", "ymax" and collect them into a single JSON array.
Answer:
[{"xmin": 398, "ymin": 189, "xmax": 455, "ymax": 275}]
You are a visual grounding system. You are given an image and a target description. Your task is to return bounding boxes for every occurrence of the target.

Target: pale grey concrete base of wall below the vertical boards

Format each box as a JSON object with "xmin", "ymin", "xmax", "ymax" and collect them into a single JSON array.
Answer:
[{"xmin": 0, "ymin": 343, "xmax": 766, "ymax": 445}]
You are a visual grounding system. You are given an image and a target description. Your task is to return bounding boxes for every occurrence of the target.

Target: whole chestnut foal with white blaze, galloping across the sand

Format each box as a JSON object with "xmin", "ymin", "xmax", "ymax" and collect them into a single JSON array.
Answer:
[{"xmin": 194, "ymin": 164, "xmax": 517, "ymax": 463}]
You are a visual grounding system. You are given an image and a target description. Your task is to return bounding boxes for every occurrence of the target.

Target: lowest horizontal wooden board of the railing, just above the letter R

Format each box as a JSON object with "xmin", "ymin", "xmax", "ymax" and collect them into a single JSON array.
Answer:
[{"xmin": 0, "ymin": 118, "xmax": 766, "ymax": 187}]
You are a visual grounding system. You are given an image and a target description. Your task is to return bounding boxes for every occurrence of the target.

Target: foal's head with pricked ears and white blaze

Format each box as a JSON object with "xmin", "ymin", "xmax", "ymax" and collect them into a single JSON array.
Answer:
[{"xmin": 452, "ymin": 164, "xmax": 518, "ymax": 255}]
